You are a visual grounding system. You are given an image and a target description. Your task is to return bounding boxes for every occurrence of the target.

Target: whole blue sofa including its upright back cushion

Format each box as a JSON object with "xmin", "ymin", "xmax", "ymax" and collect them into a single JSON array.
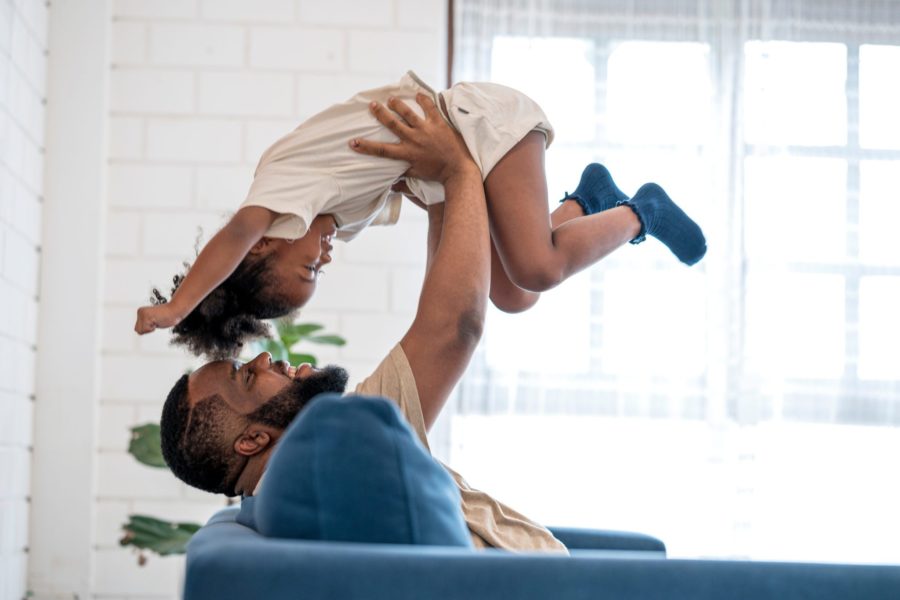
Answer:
[{"xmin": 184, "ymin": 395, "xmax": 900, "ymax": 600}]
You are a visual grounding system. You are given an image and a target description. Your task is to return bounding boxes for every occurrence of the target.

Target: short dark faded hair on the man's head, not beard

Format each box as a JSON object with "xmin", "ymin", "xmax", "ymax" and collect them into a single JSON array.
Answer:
[{"xmin": 159, "ymin": 375, "xmax": 241, "ymax": 496}]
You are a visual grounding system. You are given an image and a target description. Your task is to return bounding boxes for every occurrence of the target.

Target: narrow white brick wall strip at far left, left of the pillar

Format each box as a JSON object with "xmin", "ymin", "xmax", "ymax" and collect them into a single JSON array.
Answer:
[{"xmin": 0, "ymin": 0, "xmax": 47, "ymax": 600}]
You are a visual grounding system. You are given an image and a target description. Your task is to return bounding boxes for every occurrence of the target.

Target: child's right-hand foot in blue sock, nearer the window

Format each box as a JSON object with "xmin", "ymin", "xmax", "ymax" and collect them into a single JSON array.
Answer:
[{"xmin": 620, "ymin": 183, "xmax": 706, "ymax": 265}]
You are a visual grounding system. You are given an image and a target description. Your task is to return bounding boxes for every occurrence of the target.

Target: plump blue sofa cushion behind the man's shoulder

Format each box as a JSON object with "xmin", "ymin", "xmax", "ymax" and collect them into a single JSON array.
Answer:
[{"xmin": 254, "ymin": 394, "xmax": 472, "ymax": 546}]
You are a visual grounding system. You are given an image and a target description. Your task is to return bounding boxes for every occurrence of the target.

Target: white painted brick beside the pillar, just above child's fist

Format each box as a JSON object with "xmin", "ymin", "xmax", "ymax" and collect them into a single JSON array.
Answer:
[{"xmin": 105, "ymin": 257, "xmax": 190, "ymax": 310}]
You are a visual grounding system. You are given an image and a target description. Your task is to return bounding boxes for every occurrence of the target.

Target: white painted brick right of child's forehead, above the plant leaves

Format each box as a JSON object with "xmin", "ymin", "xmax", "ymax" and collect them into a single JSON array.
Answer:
[{"xmin": 307, "ymin": 266, "xmax": 388, "ymax": 314}]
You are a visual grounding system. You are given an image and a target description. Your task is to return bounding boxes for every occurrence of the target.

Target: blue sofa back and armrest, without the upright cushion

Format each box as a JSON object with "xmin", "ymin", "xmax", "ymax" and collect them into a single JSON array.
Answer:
[{"xmin": 184, "ymin": 507, "xmax": 900, "ymax": 600}]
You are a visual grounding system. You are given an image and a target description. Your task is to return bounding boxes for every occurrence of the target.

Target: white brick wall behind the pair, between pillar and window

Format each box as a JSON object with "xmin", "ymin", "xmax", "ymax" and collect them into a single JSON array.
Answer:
[{"xmin": 96, "ymin": 0, "xmax": 446, "ymax": 598}]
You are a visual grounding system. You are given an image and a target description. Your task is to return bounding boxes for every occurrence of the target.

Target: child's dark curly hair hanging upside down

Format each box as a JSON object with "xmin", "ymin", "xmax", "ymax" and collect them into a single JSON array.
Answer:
[{"xmin": 150, "ymin": 255, "xmax": 294, "ymax": 360}]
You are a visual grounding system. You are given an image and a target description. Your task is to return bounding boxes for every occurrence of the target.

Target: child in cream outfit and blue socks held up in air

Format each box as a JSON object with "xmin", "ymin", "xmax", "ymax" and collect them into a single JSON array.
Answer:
[{"xmin": 135, "ymin": 72, "xmax": 706, "ymax": 357}]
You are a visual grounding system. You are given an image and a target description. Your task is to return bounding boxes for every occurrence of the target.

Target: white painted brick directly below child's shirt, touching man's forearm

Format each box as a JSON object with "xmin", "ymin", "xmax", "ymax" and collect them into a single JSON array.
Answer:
[{"xmin": 344, "ymin": 219, "xmax": 427, "ymax": 265}]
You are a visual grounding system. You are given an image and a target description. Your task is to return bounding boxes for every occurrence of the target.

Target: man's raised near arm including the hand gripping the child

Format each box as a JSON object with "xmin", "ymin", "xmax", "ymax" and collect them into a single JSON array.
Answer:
[{"xmin": 351, "ymin": 95, "xmax": 490, "ymax": 428}]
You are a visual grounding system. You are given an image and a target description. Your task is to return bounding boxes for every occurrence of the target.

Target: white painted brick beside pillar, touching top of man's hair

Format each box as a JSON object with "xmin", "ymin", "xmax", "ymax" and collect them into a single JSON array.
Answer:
[{"xmin": 101, "ymin": 354, "xmax": 188, "ymax": 402}]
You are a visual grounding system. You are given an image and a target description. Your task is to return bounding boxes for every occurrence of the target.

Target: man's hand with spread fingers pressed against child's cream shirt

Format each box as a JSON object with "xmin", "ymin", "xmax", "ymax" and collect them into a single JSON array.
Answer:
[{"xmin": 350, "ymin": 94, "xmax": 477, "ymax": 183}]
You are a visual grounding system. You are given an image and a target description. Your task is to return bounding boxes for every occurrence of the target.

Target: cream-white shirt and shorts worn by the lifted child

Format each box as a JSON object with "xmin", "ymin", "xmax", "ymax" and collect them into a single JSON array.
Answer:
[{"xmin": 241, "ymin": 71, "xmax": 553, "ymax": 241}]
